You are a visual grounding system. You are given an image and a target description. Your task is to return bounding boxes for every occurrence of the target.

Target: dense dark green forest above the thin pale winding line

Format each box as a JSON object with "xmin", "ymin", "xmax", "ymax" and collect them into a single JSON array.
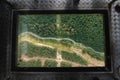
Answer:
[{"xmin": 18, "ymin": 14, "xmax": 104, "ymax": 52}]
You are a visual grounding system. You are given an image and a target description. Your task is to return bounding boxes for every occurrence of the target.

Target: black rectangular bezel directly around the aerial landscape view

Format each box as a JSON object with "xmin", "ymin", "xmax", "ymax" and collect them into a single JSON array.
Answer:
[{"xmin": 11, "ymin": 10, "xmax": 112, "ymax": 72}]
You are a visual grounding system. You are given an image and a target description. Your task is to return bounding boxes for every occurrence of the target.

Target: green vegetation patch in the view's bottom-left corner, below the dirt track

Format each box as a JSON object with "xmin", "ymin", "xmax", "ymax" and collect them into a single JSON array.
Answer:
[{"xmin": 17, "ymin": 60, "xmax": 41, "ymax": 67}]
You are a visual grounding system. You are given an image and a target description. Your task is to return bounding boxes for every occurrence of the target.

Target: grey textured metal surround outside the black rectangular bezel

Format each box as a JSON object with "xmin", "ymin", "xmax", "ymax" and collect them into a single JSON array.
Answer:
[{"xmin": 0, "ymin": 0, "xmax": 120, "ymax": 80}]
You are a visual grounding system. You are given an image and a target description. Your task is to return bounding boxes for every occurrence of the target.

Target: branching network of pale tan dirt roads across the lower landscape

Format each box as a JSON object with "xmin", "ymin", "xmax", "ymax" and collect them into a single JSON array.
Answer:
[{"xmin": 18, "ymin": 32, "xmax": 105, "ymax": 67}]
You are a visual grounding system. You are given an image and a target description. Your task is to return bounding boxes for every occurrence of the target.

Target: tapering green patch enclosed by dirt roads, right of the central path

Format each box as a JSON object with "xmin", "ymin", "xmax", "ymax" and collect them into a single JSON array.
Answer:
[{"xmin": 61, "ymin": 51, "xmax": 88, "ymax": 65}]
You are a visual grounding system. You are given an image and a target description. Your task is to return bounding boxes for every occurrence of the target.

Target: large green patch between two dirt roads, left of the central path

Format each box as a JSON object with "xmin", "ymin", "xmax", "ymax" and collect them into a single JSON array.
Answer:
[{"xmin": 18, "ymin": 42, "xmax": 56, "ymax": 58}]
